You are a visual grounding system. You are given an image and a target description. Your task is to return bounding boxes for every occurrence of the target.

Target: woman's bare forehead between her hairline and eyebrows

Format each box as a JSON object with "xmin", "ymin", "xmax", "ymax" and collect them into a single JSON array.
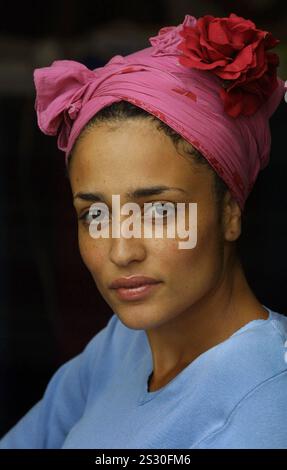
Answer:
[{"xmin": 70, "ymin": 119, "xmax": 214, "ymax": 193}]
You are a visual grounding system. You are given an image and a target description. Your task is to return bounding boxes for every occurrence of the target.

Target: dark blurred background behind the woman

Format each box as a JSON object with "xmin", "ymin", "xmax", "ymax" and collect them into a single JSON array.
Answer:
[{"xmin": 0, "ymin": 0, "xmax": 287, "ymax": 435}]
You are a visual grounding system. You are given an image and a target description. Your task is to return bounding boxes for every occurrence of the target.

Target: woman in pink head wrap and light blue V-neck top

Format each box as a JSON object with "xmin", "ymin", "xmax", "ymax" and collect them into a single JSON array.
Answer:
[{"xmin": 0, "ymin": 14, "xmax": 287, "ymax": 449}]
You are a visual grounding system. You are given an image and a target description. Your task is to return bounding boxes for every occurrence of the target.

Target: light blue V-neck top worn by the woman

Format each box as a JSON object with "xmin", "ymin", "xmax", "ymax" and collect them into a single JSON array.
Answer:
[{"xmin": 0, "ymin": 306, "xmax": 287, "ymax": 449}]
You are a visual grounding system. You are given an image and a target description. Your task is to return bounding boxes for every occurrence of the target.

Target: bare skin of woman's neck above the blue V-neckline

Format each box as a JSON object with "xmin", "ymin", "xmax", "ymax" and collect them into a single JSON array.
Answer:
[{"xmin": 148, "ymin": 253, "xmax": 268, "ymax": 392}]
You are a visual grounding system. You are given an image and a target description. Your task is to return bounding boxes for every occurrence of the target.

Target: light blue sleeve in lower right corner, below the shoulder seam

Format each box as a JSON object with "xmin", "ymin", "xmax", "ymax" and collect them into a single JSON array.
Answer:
[{"xmin": 195, "ymin": 370, "xmax": 287, "ymax": 449}]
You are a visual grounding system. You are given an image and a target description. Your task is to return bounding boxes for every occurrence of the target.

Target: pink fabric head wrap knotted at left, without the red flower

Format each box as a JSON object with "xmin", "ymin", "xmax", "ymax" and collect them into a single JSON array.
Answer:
[{"xmin": 34, "ymin": 15, "xmax": 284, "ymax": 209}]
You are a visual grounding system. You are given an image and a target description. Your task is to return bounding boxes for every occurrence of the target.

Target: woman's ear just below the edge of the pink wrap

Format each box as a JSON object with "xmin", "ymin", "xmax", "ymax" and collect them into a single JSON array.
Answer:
[{"xmin": 223, "ymin": 191, "xmax": 241, "ymax": 241}]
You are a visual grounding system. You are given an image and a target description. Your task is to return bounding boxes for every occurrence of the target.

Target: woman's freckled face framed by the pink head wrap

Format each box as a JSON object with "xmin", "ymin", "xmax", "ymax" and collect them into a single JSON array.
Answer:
[{"xmin": 70, "ymin": 119, "xmax": 230, "ymax": 330}]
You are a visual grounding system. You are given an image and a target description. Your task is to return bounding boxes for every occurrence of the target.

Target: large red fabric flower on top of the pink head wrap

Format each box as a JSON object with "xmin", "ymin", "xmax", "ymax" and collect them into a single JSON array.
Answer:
[{"xmin": 177, "ymin": 13, "xmax": 280, "ymax": 117}]
